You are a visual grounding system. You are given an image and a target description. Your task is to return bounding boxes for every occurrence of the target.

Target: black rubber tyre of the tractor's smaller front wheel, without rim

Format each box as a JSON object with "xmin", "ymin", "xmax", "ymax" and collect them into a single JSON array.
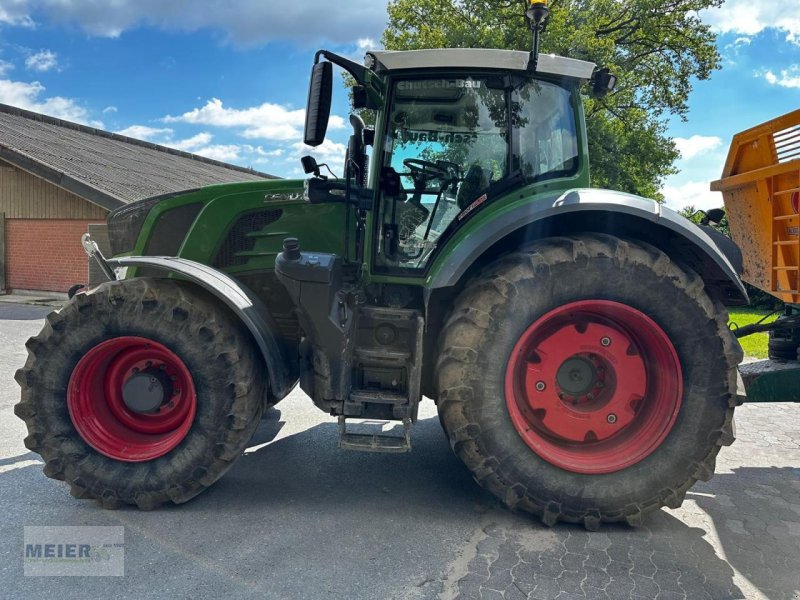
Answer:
[{"xmin": 14, "ymin": 279, "xmax": 265, "ymax": 510}]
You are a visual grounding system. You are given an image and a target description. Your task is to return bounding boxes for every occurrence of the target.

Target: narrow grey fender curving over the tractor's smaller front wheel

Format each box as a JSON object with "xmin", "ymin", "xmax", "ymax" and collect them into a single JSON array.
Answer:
[{"xmin": 106, "ymin": 256, "xmax": 297, "ymax": 401}]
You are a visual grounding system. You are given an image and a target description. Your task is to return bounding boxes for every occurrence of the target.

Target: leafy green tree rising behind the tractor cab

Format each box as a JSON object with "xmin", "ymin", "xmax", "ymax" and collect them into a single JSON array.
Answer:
[{"xmin": 383, "ymin": 0, "xmax": 723, "ymax": 200}]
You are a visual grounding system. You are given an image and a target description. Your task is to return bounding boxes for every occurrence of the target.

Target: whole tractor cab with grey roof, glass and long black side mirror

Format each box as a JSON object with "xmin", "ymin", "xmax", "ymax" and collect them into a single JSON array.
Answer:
[{"xmin": 306, "ymin": 48, "xmax": 609, "ymax": 276}]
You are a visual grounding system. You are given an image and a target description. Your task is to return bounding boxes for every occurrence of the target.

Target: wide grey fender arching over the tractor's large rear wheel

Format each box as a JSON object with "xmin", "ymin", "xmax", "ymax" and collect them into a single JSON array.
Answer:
[{"xmin": 426, "ymin": 189, "xmax": 748, "ymax": 305}]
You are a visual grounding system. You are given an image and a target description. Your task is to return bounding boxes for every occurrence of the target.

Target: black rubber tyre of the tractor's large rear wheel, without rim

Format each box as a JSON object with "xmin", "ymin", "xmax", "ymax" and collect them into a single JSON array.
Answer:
[{"xmin": 436, "ymin": 234, "xmax": 742, "ymax": 530}]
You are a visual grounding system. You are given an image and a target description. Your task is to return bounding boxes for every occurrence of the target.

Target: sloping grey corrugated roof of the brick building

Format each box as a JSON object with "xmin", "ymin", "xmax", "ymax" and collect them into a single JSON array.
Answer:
[{"xmin": 0, "ymin": 104, "xmax": 274, "ymax": 210}]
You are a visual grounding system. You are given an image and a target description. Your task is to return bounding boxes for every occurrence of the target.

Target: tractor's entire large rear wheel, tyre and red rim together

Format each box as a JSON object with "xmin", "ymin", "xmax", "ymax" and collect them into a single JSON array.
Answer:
[{"xmin": 437, "ymin": 234, "xmax": 741, "ymax": 529}]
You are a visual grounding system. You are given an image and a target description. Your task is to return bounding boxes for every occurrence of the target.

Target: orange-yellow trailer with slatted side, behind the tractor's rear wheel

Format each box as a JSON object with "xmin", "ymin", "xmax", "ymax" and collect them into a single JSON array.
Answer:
[{"xmin": 711, "ymin": 110, "xmax": 800, "ymax": 402}]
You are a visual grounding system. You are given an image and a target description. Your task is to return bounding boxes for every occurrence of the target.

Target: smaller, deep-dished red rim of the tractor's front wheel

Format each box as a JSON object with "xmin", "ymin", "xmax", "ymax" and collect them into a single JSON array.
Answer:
[{"xmin": 67, "ymin": 336, "xmax": 197, "ymax": 462}]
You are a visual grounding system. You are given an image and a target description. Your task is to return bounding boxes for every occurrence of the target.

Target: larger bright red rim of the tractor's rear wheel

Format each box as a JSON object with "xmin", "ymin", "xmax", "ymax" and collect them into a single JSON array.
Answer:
[{"xmin": 505, "ymin": 300, "xmax": 683, "ymax": 474}]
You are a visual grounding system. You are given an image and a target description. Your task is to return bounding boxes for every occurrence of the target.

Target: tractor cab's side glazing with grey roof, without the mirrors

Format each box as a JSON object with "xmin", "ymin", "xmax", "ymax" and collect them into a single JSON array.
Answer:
[{"xmin": 368, "ymin": 50, "xmax": 593, "ymax": 270}]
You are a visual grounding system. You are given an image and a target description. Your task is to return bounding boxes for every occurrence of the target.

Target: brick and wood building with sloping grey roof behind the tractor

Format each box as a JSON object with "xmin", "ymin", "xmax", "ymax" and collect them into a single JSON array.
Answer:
[{"xmin": 0, "ymin": 104, "xmax": 271, "ymax": 293}]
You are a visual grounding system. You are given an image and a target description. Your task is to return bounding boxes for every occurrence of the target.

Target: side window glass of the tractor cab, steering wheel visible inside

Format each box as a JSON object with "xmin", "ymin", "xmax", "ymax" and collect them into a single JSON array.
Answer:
[{"xmin": 377, "ymin": 77, "xmax": 578, "ymax": 269}]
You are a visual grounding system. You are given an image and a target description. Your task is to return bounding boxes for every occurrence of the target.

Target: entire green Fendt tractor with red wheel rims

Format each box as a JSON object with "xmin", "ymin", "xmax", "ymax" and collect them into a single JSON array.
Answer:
[{"xmin": 16, "ymin": 3, "xmax": 748, "ymax": 529}]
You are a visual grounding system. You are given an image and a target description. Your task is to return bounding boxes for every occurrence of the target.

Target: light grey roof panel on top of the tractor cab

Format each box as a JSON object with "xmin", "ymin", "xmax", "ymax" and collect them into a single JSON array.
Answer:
[{"xmin": 367, "ymin": 48, "xmax": 595, "ymax": 80}]
